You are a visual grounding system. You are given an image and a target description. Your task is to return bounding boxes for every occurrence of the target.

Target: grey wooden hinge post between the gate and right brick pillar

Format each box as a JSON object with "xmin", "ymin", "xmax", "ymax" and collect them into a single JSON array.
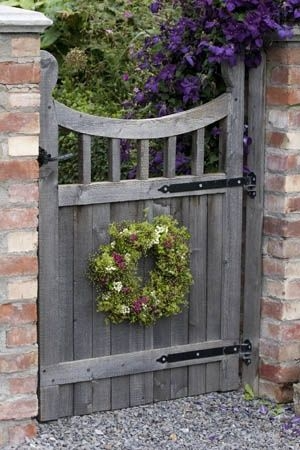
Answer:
[{"xmin": 243, "ymin": 55, "xmax": 266, "ymax": 393}]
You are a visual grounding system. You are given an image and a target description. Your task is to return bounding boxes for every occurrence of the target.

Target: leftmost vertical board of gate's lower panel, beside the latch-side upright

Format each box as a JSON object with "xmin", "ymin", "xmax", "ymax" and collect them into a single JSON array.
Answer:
[{"xmin": 59, "ymin": 207, "xmax": 74, "ymax": 417}]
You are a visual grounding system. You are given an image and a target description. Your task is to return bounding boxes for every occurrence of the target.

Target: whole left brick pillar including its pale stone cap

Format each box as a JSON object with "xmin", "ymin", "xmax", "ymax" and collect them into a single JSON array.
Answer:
[{"xmin": 0, "ymin": 6, "xmax": 51, "ymax": 447}]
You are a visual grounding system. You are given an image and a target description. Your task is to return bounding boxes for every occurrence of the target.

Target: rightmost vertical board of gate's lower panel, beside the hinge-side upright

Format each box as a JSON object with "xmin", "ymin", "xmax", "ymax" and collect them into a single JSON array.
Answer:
[{"xmin": 206, "ymin": 194, "xmax": 223, "ymax": 392}]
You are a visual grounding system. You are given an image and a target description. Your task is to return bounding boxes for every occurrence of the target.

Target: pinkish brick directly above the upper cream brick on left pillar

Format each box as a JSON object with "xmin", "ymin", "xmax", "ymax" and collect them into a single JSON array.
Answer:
[{"xmin": 0, "ymin": 112, "xmax": 39, "ymax": 134}]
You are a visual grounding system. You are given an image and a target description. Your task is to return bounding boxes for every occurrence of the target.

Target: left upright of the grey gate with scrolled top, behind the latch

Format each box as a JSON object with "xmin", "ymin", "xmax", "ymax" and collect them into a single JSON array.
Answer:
[{"xmin": 38, "ymin": 52, "xmax": 62, "ymax": 421}]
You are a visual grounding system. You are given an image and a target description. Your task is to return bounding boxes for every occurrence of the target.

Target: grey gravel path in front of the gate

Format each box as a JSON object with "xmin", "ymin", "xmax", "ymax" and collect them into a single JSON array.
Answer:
[{"xmin": 5, "ymin": 392, "xmax": 300, "ymax": 450}]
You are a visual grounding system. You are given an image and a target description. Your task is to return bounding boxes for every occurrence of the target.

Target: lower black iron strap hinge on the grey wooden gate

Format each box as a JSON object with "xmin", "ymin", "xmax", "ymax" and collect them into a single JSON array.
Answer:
[{"xmin": 157, "ymin": 339, "xmax": 252, "ymax": 366}]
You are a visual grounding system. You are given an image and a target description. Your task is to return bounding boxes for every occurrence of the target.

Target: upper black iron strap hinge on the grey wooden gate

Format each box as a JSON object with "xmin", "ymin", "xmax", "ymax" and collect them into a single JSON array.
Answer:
[{"xmin": 158, "ymin": 172, "xmax": 256, "ymax": 198}]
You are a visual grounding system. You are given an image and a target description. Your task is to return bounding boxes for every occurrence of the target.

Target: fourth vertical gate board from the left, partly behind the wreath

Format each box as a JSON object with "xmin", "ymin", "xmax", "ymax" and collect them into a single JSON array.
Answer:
[{"xmin": 111, "ymin": 202, "xmax": 138, "ymax": 409}]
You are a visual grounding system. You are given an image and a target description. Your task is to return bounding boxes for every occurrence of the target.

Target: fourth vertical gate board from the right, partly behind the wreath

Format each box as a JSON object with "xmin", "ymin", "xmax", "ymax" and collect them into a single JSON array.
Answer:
[{"xmin": 153, "ymin": 200, "xmax": 171, "ymax": 401}]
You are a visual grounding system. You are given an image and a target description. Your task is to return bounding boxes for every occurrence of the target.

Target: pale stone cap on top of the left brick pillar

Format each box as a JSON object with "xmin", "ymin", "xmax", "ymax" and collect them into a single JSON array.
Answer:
[{"xmin": 0, "ymin": 5, "xmax": 53, "ymax": 34}]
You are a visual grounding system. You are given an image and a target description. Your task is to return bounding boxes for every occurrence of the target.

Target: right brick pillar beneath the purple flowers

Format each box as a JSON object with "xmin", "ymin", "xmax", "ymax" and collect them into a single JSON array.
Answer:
[{"xmin": 260, "ymin": 31, "xmax": 300, "ymax": 402}]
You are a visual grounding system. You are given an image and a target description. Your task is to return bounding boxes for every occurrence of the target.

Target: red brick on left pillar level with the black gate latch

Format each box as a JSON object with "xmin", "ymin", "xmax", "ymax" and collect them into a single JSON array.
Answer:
[{"xmin": 0, "ymin": 160, "xmax": 39, "ymax": 181}]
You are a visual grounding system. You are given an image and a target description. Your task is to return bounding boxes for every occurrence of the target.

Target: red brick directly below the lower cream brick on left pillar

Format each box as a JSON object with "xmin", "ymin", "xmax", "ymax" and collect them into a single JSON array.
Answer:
[{"xmin": 0, "ymin": 256, "xmax": 38, "ymax": 276}]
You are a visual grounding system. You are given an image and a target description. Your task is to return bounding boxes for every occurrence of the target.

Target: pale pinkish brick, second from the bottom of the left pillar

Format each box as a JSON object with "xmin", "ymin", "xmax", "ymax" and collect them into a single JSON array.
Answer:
[{"xmin": 0, "ymin": 397, "xmax": 38, "ymax": 420}]
